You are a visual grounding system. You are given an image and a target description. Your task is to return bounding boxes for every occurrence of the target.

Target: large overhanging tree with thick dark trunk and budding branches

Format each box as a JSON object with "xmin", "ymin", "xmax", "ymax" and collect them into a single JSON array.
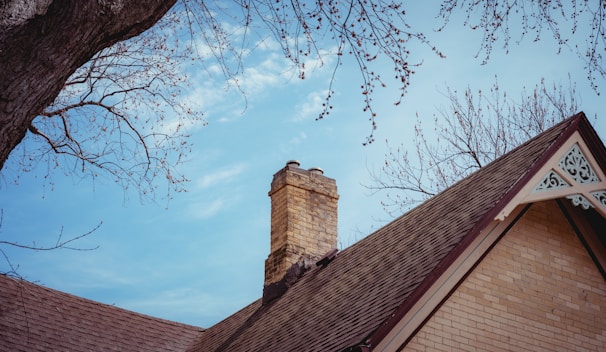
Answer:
[{"xmin": 0, "ymin": 0, "xmax": 606, "ymax": 198}]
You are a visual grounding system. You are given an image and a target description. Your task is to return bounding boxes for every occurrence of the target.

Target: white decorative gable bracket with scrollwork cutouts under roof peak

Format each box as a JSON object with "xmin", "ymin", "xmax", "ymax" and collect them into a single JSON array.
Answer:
[{"xmin": 496, "ymin": 132, "xmax": 606, "ymax": 221}]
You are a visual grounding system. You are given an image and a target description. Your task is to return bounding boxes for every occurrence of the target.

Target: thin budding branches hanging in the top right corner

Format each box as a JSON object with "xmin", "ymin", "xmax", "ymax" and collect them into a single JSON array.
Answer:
[{"xmin": 439, "ymin": 0, "xmax": 606, "ymax": 94}]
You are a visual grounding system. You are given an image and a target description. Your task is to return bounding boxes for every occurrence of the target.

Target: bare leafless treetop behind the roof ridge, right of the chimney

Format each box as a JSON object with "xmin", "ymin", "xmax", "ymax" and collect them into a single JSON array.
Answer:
[{"xmin": 367, "ymin": 78, "xmax": 578, "ymax": 216}]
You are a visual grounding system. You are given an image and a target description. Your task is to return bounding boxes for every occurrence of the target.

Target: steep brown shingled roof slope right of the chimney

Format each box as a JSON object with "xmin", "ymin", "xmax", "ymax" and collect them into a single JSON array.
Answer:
[{"xmin": 189, "ymin": 113, "xmax": 606, "ymax": 351}]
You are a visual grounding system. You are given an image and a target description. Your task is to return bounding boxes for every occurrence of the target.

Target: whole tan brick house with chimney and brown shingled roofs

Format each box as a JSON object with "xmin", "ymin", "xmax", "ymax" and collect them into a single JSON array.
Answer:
[{"xmin": 0, "ymin": 113, "xmax": 606, "ymax": 352}]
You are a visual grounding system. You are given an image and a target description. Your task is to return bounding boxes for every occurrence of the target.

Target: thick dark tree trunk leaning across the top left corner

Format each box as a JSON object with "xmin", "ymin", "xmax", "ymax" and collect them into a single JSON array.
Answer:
[{"xmin": 0, "ymin": 0, "xmax": 176, "ymax": 170}]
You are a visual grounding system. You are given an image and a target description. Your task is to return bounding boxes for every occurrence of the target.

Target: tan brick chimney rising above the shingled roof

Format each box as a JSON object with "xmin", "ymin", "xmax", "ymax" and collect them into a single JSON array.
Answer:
[{"xmin": 265, "ymin": 161, "xmax": 339, "ymax": 288}]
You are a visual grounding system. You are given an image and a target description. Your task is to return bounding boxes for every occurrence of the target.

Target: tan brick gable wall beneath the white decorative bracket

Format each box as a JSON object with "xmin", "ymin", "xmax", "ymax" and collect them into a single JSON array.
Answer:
[{"xmin": 404, "ymin": 201, "xmax": 606, "ymax": 351}]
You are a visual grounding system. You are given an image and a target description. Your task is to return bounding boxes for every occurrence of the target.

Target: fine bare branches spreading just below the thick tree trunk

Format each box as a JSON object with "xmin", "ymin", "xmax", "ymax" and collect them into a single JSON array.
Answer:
[{"xmin": 12, "ymin": 12, "xmax": 204, "ymax": 196}]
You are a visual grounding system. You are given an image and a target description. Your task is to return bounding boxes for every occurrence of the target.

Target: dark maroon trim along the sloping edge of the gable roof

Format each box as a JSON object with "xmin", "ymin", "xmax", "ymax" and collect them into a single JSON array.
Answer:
[{"xmin": 363, "ymin": 112, "xmax": 588, "ymax": 349}]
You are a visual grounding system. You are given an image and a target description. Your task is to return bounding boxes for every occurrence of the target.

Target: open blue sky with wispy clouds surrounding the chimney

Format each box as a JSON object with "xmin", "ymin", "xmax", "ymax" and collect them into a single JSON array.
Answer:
[{"xmin": 0, "ymin": 2, "xmax": 606, "ymax": 327}]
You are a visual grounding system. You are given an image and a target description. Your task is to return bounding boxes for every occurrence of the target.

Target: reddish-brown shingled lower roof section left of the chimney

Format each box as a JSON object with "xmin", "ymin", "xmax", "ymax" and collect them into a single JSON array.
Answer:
[{"xmin": 0, "ymin": 275, "xmax": 202, "ymax": 352}]
